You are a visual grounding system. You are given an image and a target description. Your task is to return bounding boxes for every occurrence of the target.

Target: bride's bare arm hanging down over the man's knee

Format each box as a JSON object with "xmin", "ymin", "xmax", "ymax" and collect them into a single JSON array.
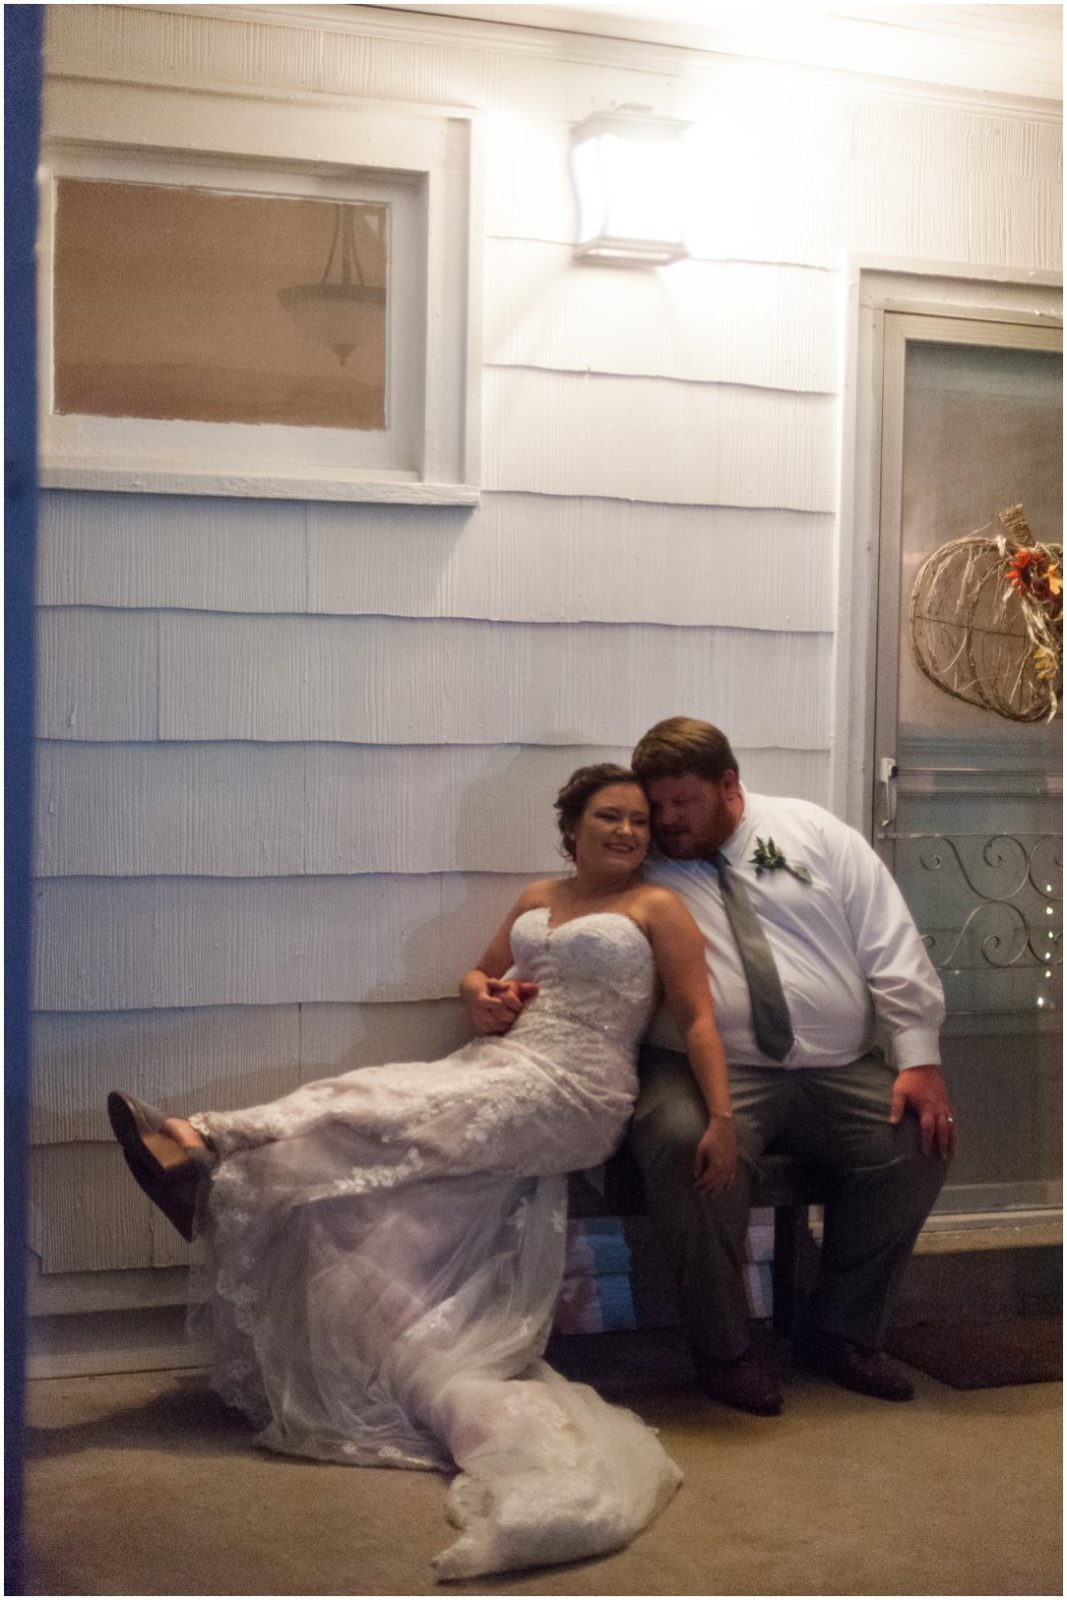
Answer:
[{"xmin": 641, "ymin": 888, "xmax": 737, "ymax": 1192}]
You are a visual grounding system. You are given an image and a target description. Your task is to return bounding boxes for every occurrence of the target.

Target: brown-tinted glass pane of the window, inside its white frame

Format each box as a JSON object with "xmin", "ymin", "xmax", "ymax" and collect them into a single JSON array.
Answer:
[{"xmin": 53, "ymin": 178, "xmax": 389, "ymax": 430}]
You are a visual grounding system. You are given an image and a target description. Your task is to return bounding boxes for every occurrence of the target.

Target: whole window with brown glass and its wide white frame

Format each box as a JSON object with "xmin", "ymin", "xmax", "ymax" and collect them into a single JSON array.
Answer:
[{"xmin": 40, "ymin": 83, "xmax": 478, "ymax": 504}]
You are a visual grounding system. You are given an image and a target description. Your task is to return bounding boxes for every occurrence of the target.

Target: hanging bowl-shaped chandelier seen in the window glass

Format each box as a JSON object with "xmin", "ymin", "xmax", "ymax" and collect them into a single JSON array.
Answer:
[{"xmin": 278, "ymin": 205, "xmax": 386, "ymax": 366}]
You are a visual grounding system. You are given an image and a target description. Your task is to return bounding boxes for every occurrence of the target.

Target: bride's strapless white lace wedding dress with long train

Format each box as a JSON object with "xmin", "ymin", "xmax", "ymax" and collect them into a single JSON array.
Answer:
[{"xmin": 192, "ymin": 909, "xmax": 681, "ymax": 1578}]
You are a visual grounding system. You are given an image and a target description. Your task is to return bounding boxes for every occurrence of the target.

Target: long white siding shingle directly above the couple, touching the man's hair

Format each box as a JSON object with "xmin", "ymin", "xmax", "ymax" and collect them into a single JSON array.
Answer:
[{"xmin": 160, "ymin": 614, "xmax": 830, "ymax": 749}]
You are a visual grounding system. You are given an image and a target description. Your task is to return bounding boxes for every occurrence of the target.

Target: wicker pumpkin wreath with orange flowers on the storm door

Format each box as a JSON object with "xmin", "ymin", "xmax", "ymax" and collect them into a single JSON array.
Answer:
[{"xmin": 909, "ymin": 506, "xmax": 1064, "ymax": 722}]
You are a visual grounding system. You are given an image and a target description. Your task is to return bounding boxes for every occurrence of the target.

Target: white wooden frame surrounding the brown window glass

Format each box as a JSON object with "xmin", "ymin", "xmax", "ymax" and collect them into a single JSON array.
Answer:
[{"xmin": 38, "ymin": 80, "xmax": 482, "ymax": 506}]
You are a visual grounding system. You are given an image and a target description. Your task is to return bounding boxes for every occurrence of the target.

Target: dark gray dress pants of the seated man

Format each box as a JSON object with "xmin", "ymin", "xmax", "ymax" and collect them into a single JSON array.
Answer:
[{"xmin": 629, "ymin": 1046, "xmax": 947, "ymax": 1363}]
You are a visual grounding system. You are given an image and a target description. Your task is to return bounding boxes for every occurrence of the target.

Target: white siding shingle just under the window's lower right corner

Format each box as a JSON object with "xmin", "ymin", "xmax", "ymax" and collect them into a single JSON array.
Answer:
[{"xmin": 307, "ymin": 493, "xmax": 833, "ymax": 632}]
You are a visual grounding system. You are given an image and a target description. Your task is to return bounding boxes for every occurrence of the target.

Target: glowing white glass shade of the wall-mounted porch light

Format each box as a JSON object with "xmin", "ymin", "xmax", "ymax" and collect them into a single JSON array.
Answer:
[{"xmin": 571, "ymin": 107, "xmax": 689, "ymax": 266}]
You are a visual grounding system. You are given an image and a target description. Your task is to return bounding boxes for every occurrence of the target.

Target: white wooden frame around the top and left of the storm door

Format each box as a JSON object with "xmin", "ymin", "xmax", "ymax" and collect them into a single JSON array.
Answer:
[{"xmin": 830, "ymin": 254, "xmax": 1062, "ymax": 840}]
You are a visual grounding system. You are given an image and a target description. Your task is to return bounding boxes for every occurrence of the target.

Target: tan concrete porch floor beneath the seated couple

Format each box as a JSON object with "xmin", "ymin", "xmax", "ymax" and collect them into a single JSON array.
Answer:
[{"xmin": 26, "ymin": 1331, "xmax": 1062, "ymax": 1595}]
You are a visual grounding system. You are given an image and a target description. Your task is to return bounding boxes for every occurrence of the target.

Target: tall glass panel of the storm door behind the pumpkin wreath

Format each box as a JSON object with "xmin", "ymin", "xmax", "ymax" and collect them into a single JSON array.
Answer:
[{"xmin": 880, "ymin": 334, "xmax": 1062, "ymax": 1210}]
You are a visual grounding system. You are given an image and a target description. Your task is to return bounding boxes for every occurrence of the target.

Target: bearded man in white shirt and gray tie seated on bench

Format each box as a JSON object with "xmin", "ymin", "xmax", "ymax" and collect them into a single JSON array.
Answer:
[{"xmin": 630, "ymin": 717, "xmax": 955, "ymax": 1416}]
